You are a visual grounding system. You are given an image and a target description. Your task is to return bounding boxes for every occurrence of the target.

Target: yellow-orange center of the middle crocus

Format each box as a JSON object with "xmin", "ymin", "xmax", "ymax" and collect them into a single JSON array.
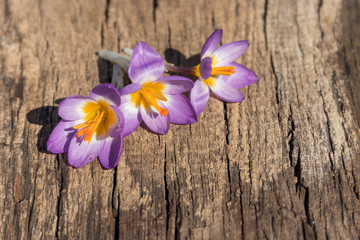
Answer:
[{"xmin": 130, "ymin": 82, "xmax": 168, "ymax": 116}]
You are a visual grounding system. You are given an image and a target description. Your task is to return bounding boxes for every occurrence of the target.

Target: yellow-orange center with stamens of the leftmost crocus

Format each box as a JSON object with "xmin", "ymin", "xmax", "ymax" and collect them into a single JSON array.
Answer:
[{"xmin": 73, "ymin": 100, "xmax": 116, "ymax": 143}]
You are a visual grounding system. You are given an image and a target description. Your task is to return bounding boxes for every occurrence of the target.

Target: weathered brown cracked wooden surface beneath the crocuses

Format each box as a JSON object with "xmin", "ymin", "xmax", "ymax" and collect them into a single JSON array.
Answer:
[{"xmin": 0, "ymin": 0, "xmax": 360, "ymax": 239}]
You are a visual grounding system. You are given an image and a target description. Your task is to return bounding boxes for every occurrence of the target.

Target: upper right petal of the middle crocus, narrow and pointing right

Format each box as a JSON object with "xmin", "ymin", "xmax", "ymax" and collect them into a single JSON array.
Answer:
[{"xmin": 155, "ymin": 76, "xmax": 194, "ymax": 94}]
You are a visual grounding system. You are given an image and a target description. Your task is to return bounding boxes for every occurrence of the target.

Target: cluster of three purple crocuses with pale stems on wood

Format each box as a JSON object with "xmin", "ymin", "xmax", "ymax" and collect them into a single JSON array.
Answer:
[{"xmin": 47, "ymin": 29, "xmax": 258, "ymax": 169}]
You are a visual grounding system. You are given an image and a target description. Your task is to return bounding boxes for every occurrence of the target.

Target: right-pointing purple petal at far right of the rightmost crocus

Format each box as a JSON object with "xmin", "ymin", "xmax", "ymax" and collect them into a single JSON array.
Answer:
[{"xmin": 219, "ymin": 63, "xmax": 259, "ymax": 88}]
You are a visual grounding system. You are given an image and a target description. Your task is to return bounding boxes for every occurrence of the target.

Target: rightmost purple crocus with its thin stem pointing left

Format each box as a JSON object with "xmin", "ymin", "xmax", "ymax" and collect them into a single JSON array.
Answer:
[{"xmin": 166, "ymin": 29, "xmax": 258, "ymax": 115}]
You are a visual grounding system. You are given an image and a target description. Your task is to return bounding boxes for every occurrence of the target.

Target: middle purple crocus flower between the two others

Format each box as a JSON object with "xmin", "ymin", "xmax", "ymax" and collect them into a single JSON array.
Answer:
[{"xmin": 120, "ymin": 42, "xmax": 197, "ymax": 137}]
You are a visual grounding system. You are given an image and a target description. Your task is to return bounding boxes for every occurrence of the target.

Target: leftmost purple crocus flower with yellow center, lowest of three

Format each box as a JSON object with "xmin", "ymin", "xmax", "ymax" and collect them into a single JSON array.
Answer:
[{"xmin": 47, "ymin": 83, "xmax": 124, "ymax": 168}]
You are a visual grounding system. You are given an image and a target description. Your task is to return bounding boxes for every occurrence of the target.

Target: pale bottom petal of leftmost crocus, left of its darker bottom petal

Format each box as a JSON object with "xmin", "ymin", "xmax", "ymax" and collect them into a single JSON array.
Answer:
[{"xmin": 68, "ymin": 134, "xmax": 105, "ymax": 168}]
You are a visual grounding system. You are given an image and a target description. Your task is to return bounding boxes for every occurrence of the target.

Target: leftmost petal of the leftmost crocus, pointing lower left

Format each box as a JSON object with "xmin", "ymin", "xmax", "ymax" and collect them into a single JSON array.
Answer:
[{"xmin": 47, "ymin": 120, "xmax": 76, "ymax": 153}]
